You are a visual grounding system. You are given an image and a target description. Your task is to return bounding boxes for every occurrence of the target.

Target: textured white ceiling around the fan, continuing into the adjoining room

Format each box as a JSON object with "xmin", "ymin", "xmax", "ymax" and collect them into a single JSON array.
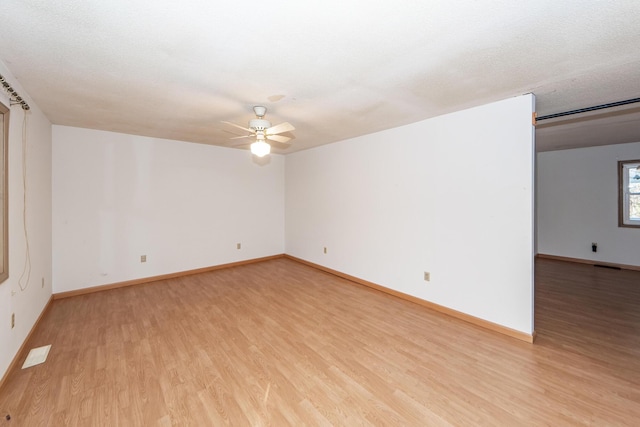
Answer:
[{"xmin": 0, "ymin": 0, "xmax": 640, "ymax": 153}]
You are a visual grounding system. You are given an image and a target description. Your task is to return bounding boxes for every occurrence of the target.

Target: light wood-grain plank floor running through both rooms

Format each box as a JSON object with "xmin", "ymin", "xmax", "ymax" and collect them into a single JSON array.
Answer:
[{"xmin": 0, "ymin": 259, "xmax": 640, "ymax": 427}]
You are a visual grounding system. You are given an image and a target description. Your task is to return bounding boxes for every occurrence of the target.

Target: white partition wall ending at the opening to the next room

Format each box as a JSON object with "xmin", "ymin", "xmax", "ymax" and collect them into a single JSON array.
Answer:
[{"xmin": 285, "ymin": 95, "xmax": 534, "ymax": 333}]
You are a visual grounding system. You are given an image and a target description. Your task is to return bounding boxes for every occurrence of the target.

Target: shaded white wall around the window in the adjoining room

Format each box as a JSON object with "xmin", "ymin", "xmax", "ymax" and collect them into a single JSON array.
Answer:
[{"xmin": 537, "ymin": 142, "xmax": 640, "ymax": 266}]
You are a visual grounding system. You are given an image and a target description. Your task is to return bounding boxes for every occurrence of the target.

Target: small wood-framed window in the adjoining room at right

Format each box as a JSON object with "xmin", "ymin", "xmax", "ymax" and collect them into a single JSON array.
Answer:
[{"xmin": 618, "ymin": 160, "xmax": 640, "ymax": 227}]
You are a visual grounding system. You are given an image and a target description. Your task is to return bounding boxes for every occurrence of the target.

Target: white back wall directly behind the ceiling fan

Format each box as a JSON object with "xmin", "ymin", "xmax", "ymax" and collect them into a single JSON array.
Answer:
[{"xmin": 53, "ymin": 126, "xmax": 284, "ymax": 293}]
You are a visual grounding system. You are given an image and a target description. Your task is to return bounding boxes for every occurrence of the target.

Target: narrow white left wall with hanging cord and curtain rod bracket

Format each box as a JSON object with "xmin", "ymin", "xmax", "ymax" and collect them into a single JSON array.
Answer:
[{"xmin": 0, "ymin": 62, "xmax": 51, "ymax": 378}]
